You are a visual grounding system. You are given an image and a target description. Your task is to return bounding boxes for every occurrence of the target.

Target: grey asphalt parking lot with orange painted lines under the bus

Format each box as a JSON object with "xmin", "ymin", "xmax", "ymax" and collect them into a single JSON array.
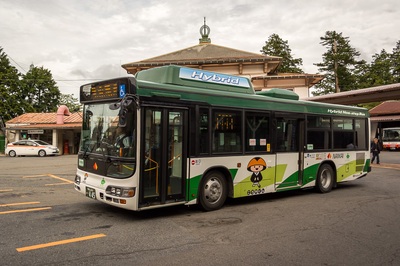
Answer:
[{"xmin": 0, "ymin": 152, "xmax": 400, "ymax": 265}]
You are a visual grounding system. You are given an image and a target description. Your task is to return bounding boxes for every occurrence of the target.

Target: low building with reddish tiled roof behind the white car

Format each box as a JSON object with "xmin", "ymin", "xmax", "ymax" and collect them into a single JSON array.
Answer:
[{"xmin": 5, "ymin": 105, "xmax": 82, "ymax": 154}]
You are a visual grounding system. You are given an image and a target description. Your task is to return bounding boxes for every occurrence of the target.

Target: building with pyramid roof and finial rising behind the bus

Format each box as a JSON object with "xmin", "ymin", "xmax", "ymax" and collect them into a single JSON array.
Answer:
[{"xmin": 122, "ymin": 19, "xmax": 324, "ymax": 98}]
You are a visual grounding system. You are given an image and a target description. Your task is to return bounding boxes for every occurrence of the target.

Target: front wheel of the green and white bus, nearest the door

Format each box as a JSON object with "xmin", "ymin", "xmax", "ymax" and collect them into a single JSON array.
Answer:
[{"xmin": 198, "ymin": 171, "xmax": 228, "ymax": 211}]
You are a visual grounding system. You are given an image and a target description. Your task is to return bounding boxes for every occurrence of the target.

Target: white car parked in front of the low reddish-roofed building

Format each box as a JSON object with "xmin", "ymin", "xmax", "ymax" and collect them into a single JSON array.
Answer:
[{"xmin": 5, "ymin": 140, "xmax": 59, "ymax": 157}]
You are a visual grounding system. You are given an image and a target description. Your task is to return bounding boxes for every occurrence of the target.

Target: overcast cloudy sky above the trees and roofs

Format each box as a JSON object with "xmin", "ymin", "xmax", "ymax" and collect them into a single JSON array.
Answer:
[{"xmin": 0, "ymin": 0, "xmax": 400, "ymax": 97}]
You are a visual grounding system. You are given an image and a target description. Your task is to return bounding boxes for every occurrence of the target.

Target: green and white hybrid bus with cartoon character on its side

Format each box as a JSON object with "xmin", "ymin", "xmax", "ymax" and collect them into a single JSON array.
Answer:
[{"xmin": 74, "ymin": 65, "xmax": 370, "ymax": 211}]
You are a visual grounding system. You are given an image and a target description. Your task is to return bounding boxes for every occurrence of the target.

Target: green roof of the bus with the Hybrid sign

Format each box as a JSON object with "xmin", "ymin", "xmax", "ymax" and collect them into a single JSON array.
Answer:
[{"xmin": 135, "ymin": 65, "xmax": 369, "ymax": 118}]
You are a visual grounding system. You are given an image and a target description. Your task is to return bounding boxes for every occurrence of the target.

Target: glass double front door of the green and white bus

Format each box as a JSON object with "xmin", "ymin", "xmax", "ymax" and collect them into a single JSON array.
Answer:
[{"xmin": 139, "ymin": 107, "xmax": 188, "ymax": 207}]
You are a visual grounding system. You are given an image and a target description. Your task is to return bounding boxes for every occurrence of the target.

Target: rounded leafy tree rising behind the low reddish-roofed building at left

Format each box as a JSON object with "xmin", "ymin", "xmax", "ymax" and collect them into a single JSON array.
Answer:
[{"xmin": 21, "ymin": 65, "xmax": 61, "ymax": 113}]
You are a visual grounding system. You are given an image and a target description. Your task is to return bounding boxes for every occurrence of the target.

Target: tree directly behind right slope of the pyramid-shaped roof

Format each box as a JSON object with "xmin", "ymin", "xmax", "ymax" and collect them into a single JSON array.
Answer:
[{"xmin": 261, "ymin": 34, "xmax": 304, "ymax": 73}]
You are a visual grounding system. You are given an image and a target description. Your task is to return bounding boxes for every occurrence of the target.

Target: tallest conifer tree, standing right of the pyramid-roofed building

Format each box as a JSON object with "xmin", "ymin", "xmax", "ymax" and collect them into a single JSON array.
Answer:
[{"xmin": 314, "ymin": 31, "xmax": 366, "ymax": 95}]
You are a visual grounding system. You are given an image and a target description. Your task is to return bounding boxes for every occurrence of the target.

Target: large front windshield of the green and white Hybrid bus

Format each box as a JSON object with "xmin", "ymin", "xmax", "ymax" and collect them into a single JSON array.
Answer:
[{"xmin": 80, "ymin": 103, "xmax": 135, "ymax": 158}]
